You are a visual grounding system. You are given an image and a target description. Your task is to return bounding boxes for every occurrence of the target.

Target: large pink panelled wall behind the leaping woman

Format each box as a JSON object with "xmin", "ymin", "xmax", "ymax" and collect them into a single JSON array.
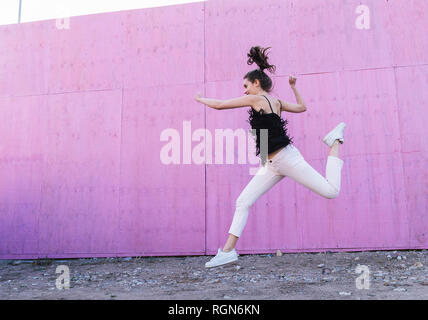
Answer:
[{"xmin": 0, "ymin": 0, "xmax": 428, "ymax": 259}]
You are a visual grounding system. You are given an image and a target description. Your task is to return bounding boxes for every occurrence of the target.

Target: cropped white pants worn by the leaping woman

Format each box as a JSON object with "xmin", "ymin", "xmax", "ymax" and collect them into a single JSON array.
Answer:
[{"xmin": 229, "ymin": 144, "xmax": 343, "ymax": 237}]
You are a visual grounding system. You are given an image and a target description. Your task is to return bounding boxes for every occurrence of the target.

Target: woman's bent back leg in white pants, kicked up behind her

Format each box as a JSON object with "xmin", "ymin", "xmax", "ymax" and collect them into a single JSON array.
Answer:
[{"xmin": 278, "ymin": 142, "xmax": 343, "ymax": 199}]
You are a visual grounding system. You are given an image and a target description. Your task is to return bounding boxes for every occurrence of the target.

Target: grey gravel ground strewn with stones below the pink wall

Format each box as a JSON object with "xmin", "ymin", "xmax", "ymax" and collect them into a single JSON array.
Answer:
[{"xmin": 0, "ymin": 250, "xmax": 428, "ymax": 300}]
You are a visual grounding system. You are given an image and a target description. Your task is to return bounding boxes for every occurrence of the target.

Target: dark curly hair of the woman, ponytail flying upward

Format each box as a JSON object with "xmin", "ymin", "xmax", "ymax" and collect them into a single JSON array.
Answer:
[{"xmin": 243, "ymin": 46, "xmax": 276, "ymax": 92}]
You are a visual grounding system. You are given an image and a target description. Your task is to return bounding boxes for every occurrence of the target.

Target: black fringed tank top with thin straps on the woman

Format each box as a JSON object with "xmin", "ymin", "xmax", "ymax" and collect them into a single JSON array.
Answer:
[{"xmin": 247, "ymin": 95, "xmax": 293, "ymax": 165}]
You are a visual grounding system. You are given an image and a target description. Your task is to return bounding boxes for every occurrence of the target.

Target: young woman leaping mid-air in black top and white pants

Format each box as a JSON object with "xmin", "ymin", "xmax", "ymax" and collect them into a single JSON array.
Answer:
[{"xmin": 195, "ymin": 46, "xmax": 346, "ymax": 268}]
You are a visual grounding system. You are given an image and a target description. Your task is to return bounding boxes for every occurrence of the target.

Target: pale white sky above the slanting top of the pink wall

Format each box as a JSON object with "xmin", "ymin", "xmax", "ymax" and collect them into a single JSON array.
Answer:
[{"xmin": 0, "ymin": 0, "xmax": 206, "ymax": 25}]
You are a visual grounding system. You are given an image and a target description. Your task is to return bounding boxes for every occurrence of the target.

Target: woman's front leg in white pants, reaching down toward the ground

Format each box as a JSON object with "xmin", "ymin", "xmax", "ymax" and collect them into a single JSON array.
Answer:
[{"xmin": 223, "ymin": 164, "xmax": 284, "ymax": 252}]
